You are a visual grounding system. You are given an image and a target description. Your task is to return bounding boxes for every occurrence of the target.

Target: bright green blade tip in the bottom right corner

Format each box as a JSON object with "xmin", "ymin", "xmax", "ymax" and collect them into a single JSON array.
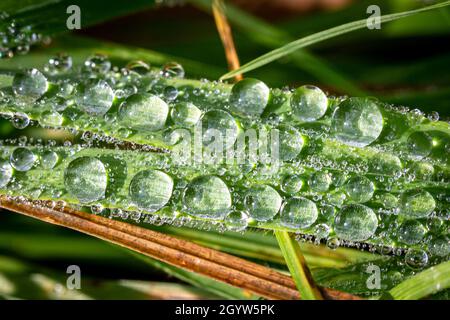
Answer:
[{"xmin": 389, "ymin": 261, "xmax": 450, "ymax": 300}]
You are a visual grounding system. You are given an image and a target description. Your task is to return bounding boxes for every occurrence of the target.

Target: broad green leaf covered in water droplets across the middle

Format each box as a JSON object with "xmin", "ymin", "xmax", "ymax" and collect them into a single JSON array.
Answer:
[{"xmin": 0, "ymin": 55, "xmax": 450, "ymax": 264}]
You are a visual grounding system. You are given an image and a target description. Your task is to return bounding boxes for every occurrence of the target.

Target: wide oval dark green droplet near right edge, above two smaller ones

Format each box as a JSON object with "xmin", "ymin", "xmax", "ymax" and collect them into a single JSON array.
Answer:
[{"xmin": 400, "ymin": 190, "xmax": 436, "ymax": 218}]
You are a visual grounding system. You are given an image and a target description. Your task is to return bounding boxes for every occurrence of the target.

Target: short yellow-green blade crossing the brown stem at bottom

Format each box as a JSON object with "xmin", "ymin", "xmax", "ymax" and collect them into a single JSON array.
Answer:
[{"xmin": 275, "ymin": 231, "xmax": 323, "ymax": 300}]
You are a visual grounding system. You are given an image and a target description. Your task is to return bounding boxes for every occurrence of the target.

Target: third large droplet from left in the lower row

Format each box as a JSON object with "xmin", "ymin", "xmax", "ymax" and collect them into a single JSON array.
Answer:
[{"xmin": 183, "ymin": 176, "xmax": 231, "ymax": 219}]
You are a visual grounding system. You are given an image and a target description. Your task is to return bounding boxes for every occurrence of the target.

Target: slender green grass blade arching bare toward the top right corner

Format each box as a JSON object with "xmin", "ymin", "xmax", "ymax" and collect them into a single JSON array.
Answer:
[{"xmin": 221, "ymin": 1, "xmax": 450, "ymax": 80}]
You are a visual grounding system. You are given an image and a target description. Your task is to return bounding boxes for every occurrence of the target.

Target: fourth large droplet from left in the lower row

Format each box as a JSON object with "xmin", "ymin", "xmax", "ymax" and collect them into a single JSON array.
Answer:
[{"xmin": 244, "ymin": 185, "xmax": 282, "ymax": 221}]
